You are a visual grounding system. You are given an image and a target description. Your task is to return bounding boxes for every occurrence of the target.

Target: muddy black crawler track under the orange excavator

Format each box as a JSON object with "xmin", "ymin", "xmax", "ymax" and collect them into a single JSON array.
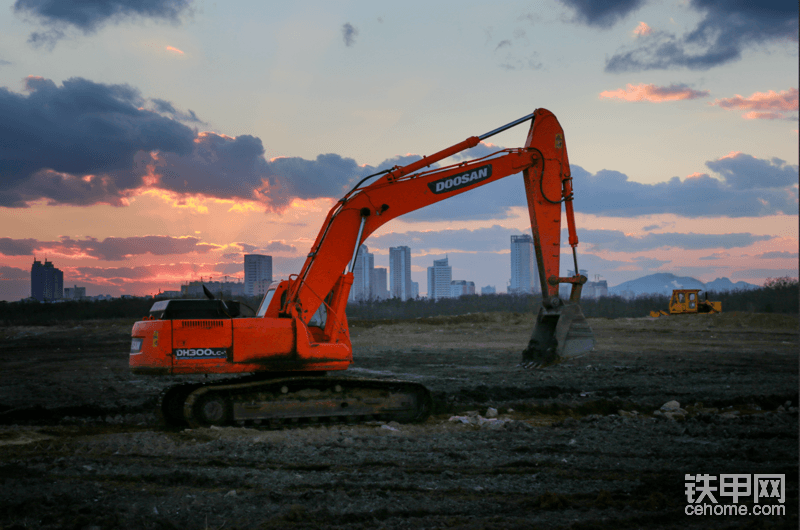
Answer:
[{"xmin": 157, "ymin": 376, "xmax": 432, "ymax": 428}]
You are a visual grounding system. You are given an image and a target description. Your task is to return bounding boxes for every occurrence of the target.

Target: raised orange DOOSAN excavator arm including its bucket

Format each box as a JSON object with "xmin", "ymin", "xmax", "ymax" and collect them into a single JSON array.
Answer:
[{"xmin": 280, "ymin": 109, "xmax": 593, "ymax": 366}]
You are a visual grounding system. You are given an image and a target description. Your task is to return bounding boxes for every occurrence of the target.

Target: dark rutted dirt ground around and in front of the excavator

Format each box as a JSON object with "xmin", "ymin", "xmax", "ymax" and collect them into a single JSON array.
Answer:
[{"xmin": 0, "ymin": 313, "xmax": 798, "ymax": 530}]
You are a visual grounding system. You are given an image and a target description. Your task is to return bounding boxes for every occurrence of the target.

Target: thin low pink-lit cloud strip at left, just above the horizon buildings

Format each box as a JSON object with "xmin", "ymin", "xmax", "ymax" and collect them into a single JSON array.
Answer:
[{"xmin": 0, "ymin": 236, "xmax": 221, "ymax": 261}]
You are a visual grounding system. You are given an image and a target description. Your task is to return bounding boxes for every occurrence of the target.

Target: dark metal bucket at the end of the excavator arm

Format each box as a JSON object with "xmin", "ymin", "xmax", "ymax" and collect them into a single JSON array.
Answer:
[{"xmin": 521, "ymin": 304, "xmax": 594, "ymax": 368}]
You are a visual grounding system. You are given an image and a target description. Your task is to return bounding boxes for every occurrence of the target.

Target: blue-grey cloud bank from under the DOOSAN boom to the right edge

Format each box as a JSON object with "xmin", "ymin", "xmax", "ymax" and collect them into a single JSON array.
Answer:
[{"xmin": 410, "ymin": 153, "xmax": 798, "ymax": 221}]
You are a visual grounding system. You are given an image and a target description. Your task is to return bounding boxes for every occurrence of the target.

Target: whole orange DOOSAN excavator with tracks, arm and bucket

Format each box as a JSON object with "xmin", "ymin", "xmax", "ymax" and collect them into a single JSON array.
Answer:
[{"xmin": 130, "ymin": 109, "xmax": 594, "ymax": 427}]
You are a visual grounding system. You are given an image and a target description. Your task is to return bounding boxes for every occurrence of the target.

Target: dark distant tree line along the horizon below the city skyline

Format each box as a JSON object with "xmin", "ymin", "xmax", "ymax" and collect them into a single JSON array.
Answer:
[{"xmin": 0, "ymin": 277, "xmax": 800, "ymax": 326}]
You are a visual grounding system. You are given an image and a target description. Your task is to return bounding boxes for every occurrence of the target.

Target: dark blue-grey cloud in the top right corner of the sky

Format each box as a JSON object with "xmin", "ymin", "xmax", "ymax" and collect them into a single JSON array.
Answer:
[{"xmin": 608, "ymin": 0, "xmax": 798, "ymax": 73}]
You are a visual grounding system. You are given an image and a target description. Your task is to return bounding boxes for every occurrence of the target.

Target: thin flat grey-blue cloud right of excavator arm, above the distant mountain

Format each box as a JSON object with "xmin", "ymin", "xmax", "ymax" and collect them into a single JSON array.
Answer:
[{"xmin": 580, "ymin": 228, "xmax": 773, "ymax": 252}]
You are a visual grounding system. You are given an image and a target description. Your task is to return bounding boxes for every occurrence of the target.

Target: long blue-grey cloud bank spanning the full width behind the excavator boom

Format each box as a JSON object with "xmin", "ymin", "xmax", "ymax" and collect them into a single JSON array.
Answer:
[{"xmin": 0, "ymin": 77, "xmax": 797, "ymax": 220}]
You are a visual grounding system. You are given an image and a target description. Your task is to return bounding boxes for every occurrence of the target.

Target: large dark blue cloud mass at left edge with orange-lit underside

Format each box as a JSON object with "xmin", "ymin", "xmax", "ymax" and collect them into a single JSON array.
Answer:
[{"xmin": 0, "ymin": 77, "xmax": 195, "ymax": 206}]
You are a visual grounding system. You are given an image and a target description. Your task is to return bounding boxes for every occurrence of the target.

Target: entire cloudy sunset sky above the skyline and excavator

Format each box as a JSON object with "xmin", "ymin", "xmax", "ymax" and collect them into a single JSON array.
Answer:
[{"xmin": 0, "ymin": 0, "xmax": 799, "ymax": 300}]
